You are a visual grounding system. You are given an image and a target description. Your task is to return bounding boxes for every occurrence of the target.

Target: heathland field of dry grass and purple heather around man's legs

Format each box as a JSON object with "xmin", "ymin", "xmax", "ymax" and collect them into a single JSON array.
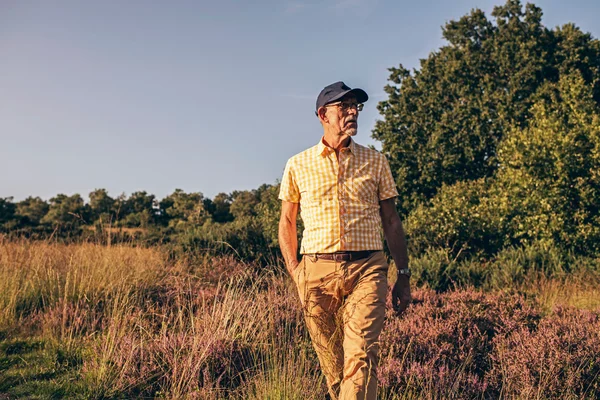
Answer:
[{"xmin": 0, "ymin": 241, "xmax": 600, "ymax": 399}]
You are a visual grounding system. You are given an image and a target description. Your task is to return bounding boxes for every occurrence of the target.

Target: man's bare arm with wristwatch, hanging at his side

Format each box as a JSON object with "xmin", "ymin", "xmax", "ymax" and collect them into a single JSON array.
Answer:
[{"xmin": 379, "ymin": 197, "xmax": 411, "ymax": 313}]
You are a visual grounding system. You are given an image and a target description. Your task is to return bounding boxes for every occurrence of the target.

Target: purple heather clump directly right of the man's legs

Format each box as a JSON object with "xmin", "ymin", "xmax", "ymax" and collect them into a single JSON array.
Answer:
[{"xmin": 380, "ymin": 290, "xmax": 540, "ymax": 398}]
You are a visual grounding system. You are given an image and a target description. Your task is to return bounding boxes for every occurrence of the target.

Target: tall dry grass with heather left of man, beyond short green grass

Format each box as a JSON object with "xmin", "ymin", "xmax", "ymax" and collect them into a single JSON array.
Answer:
[{"xmin": 0, "ymin": 241, "xmax": 319, "ymax": 399}]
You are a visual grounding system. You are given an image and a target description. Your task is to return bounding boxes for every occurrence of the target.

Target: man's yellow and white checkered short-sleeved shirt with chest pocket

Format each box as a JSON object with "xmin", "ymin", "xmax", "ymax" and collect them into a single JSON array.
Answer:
[{"xmin": 279, "ymin": 139, "xmax": 398, "ymax": 254}]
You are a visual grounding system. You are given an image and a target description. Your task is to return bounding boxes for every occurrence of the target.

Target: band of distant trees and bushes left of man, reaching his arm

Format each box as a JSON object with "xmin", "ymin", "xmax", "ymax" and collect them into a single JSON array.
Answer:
[{"xmin": 0, "ymin": 184, "xmax": 280, "ymax": 258}]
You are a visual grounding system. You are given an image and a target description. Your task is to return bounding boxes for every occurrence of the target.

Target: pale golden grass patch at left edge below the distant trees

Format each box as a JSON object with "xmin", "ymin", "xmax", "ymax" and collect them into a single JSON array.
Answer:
[{"xmin": 0, "ymin": 241, "xmax": 167, "ymax": 327}]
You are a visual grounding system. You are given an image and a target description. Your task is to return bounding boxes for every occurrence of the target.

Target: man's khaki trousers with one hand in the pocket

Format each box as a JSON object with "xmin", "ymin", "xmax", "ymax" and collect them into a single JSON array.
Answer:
[{"xmin": 294, "ymin": 251, "xmax": 388, "ymax": 400}]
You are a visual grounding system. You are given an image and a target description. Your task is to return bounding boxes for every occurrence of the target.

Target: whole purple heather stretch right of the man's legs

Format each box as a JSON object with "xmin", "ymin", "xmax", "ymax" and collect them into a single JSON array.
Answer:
[{"xmin": 379, "ymin": 290, "xmax": 600, "ymax": 399}]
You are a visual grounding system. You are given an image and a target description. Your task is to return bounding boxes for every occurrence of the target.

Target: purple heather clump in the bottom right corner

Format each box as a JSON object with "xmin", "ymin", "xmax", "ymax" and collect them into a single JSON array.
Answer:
[{"xmin": 489, "ymin": 308, "xmax": 600, "ymax": 399}]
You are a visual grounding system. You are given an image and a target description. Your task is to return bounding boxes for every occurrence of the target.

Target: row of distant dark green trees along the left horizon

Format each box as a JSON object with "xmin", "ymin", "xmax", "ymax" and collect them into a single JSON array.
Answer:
[{"xmin": 0, "ymin": 185, "xmax": 270, "ymax": 231}]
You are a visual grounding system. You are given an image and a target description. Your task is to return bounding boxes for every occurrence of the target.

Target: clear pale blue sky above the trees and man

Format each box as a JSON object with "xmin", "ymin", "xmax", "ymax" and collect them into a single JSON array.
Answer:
[{"xmin": 0, "ymin": 0, "xmax": 600, "ymax": 201}]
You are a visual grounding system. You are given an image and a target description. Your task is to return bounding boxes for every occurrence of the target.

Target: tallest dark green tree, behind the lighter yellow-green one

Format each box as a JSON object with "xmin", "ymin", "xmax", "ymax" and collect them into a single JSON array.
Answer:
[{"xmin": 373, "ymin": 0, "xmax": 600, "ymax": 214}]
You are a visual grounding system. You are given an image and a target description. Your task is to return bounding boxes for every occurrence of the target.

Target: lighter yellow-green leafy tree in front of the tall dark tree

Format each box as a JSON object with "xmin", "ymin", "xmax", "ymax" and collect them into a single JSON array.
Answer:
[{"xmin": 407, "ymin": 73, "xmax": 600, "ymax": 255}]
